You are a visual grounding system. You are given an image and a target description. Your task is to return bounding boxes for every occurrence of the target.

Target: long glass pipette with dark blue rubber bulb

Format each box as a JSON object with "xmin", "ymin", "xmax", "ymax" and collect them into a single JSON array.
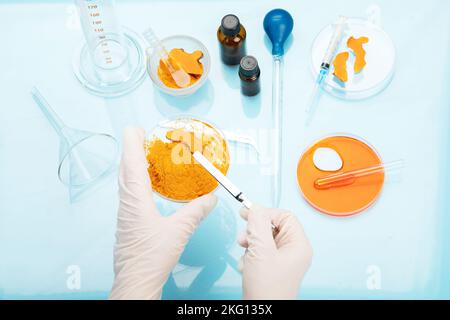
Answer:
[{"xmin": 263, "ymin": 9, "xmax": 294, "ymax": 207}]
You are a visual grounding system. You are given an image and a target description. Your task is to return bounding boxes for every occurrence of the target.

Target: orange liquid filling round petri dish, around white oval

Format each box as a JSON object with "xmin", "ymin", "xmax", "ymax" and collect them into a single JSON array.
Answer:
[{"xmin": 297, "ymin": 136, "xmax": 384, "ymax": 216}]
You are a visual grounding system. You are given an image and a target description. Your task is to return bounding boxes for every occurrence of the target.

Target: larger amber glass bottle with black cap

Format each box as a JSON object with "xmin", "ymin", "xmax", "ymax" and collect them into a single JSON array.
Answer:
[{"xmin": 217, "ymin": 14, "xmax": 247, "ymax": 65}]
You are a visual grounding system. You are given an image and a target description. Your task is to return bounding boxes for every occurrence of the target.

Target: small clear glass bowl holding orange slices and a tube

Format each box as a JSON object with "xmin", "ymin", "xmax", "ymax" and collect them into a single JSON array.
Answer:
[{"xmin": 147, "ymin": 35, "xmax": 211, "ymax": 96}]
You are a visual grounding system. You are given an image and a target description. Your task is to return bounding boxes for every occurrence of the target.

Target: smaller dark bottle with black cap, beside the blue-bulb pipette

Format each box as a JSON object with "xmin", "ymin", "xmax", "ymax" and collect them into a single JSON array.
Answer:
[{"xmin": 239, "ymin": 56, "xmax": 261, "ymax": 96}]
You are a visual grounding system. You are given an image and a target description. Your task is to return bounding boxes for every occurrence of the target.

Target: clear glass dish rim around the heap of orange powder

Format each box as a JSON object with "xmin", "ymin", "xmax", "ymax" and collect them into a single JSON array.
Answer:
[{"xmin": 145, "ymin": 116, "xmax": 230, "ymax": 203}]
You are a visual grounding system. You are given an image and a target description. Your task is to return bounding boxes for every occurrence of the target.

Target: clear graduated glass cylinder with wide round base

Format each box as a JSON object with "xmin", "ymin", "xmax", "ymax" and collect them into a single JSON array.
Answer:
[{"xmin": 73, "ymin": 0, "xmax": 145, "ymax": 97}]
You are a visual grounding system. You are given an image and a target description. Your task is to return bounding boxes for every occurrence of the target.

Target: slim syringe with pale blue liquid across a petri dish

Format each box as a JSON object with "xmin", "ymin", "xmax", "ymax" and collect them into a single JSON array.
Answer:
[{"xmin": 305, "ymin": 16, "xmax": 347, "ymax": 124}]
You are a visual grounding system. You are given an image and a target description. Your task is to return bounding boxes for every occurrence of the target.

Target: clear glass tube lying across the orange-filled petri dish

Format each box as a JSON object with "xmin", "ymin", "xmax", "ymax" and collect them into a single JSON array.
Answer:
[{"xmin": 314, "ymin": 160, "xmax": 404, "ymax": 189}]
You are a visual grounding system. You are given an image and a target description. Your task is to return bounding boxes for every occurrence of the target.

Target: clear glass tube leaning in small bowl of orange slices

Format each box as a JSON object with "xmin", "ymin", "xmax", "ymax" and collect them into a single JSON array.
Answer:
[{"xmin": 142, "ymin": 28, "xmax": 191, "ymax": 88}]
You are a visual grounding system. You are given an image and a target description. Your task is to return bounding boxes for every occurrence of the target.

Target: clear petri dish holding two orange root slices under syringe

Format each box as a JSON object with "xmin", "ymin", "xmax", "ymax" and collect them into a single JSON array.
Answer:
[{"xmin": 311, "ymin": 18, "xmax": 395, "ymax": 100}]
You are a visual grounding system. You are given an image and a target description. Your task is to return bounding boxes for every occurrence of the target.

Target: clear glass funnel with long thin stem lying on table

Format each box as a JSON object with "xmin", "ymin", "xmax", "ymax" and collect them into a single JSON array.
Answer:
[{"xmin": 31, "ymin": 87, "xmax": 119, "ymax": 200}]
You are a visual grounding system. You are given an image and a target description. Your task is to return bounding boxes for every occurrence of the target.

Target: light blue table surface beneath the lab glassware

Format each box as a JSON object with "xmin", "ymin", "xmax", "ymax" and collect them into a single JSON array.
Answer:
[{"xmin": 0, "ymin": 0, "xmax": 450, "ymax": 299}]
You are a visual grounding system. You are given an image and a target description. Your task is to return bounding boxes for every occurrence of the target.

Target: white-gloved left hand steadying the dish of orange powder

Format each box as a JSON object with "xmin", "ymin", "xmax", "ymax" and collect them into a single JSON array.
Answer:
[{"xmin": 109, "ymin": 128, "xmax": 217, "ymax": 299}]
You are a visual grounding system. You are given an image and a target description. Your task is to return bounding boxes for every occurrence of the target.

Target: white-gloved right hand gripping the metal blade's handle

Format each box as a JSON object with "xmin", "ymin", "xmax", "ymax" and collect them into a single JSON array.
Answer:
[{"xmin": 239, "ymin": 205, "xmax": 312, "ymax": 300}]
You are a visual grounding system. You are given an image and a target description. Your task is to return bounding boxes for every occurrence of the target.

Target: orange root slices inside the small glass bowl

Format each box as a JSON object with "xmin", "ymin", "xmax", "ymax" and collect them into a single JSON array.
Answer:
[{"xmin": 158, "ymin": 49, "xmax": 203, "ymax": 88}]
